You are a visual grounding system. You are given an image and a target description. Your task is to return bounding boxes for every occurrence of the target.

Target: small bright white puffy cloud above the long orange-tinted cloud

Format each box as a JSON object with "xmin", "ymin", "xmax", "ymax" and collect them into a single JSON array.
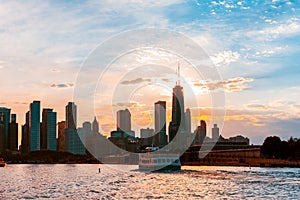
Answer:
[{"xmin": 210, "ymin": 51, "xmax": 240, "ymax": 66}]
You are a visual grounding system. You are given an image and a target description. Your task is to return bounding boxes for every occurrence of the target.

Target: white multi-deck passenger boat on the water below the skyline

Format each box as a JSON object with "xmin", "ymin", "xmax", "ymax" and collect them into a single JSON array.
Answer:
[{"xmin": 139, "ymin": 147, "xmax": 181, "ymax": 172}]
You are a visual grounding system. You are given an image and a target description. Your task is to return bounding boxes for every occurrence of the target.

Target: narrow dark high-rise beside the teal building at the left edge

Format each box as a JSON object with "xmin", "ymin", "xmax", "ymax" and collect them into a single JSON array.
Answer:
[{"xmin": 8, "ymin": 114, "xmax": 19, "ymax": 151}]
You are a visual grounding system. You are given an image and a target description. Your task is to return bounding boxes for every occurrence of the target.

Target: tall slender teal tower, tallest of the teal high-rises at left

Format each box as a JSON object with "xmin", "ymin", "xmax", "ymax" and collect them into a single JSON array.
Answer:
[{"xmin": 29, "ymin": 101, "xmax": 41, "ymax": 151}]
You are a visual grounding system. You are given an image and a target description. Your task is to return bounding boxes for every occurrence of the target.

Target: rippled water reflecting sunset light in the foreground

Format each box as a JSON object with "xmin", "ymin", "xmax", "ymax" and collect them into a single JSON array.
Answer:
[{"xmin": 0, "ymin": 165, "xmax": 300, "ymax": 199}]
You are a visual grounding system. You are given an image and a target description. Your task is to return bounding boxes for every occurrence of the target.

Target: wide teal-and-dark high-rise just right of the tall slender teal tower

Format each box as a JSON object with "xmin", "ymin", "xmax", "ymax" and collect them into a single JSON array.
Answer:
[{"xmin": 40, "ymin": 108, "xmax": 57, "ymax": 151}]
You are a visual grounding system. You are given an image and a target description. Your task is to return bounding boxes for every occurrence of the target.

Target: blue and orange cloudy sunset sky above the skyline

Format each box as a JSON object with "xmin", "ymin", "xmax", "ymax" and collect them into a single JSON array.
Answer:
[{"xmin": 0, "ymin": 0, "xmax": 300, "ymax": 144}]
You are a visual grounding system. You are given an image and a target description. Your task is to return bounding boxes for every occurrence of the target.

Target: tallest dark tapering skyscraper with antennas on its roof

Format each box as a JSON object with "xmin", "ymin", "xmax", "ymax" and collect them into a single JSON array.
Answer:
[{"xmin": 169, "ymin": 65, "xmax": 185, "ymax": 142}]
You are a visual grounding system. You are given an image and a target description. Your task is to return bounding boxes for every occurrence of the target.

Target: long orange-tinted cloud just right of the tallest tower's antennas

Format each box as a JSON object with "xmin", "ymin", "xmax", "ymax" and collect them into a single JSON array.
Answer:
[{"xmin": 194, "ymin": 77, "xmax": 254, "ymax": 92}]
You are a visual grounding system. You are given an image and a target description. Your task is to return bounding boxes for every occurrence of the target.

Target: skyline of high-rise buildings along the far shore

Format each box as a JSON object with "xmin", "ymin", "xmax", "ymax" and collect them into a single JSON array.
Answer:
[{"xmin": 0, "ymin": 66, "xmax": 249, "ymax": 154}]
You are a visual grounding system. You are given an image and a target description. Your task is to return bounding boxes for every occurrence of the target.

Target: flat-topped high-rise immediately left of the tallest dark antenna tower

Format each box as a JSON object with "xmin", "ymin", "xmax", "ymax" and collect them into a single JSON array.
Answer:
[{"xmin": 154, "ymin": 101, "xmax": 167, "ymax": 147}]
